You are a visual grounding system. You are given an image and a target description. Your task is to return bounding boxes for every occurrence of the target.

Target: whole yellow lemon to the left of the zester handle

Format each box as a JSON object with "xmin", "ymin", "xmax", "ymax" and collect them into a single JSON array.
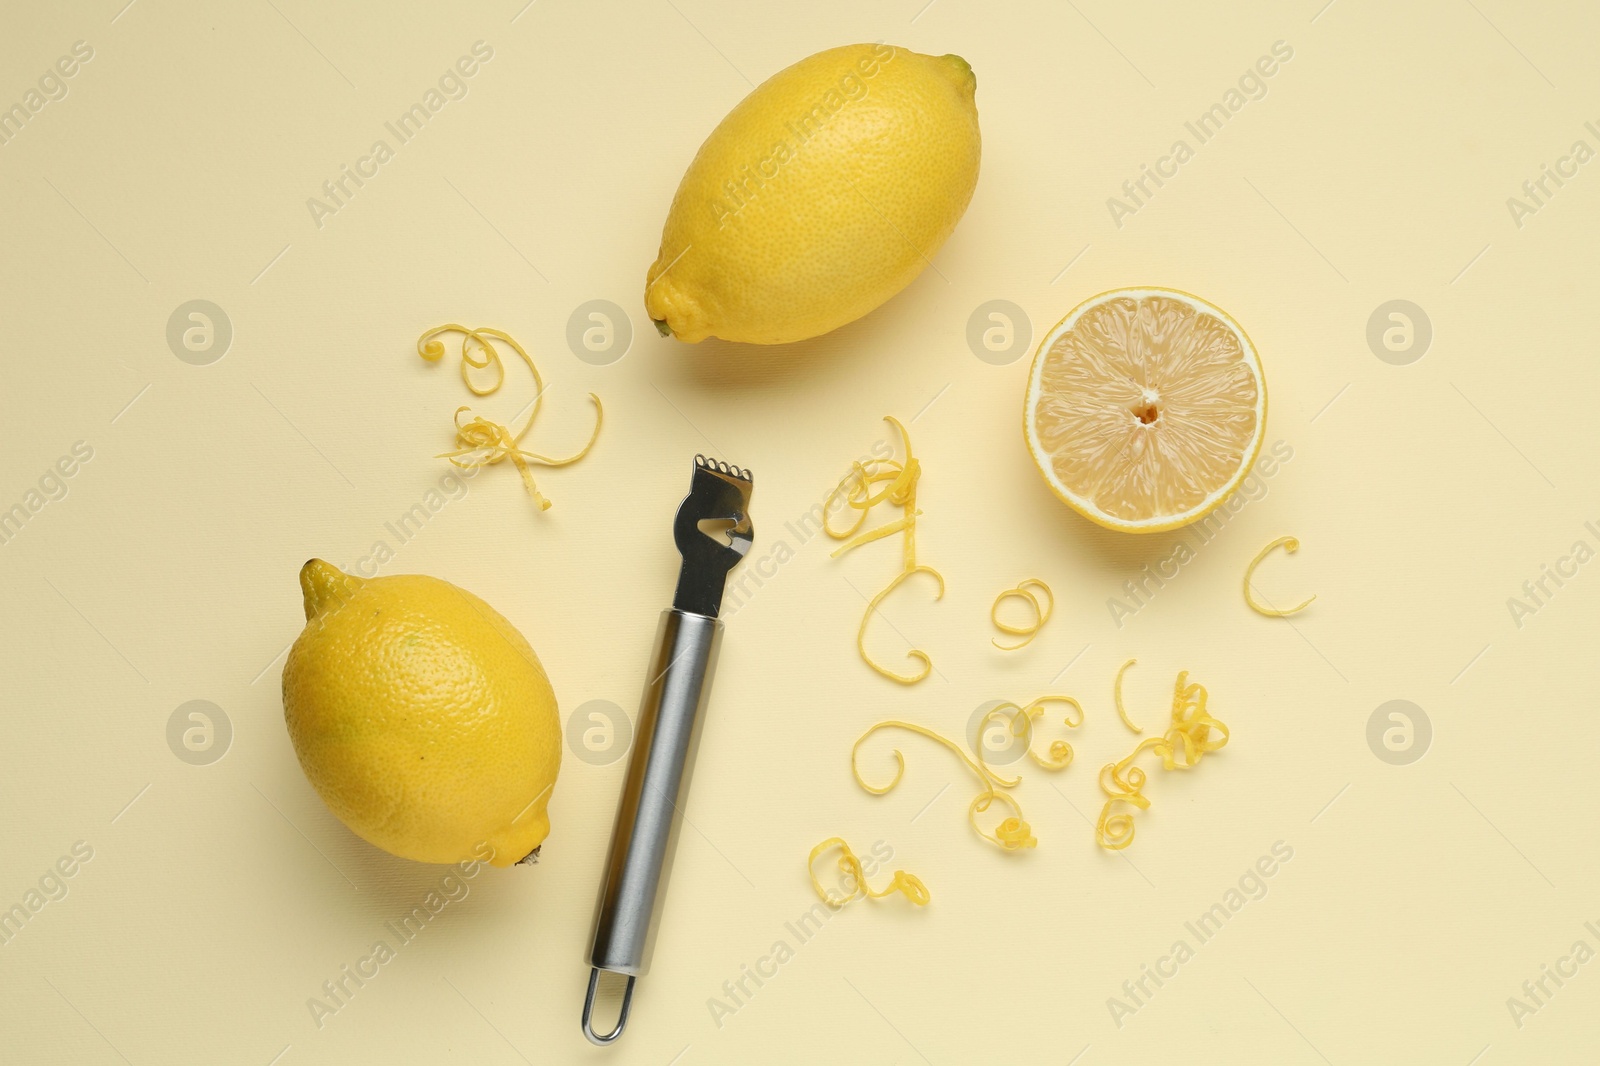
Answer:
[{"xmin": 283, "ymin": 559, "xmax": 562, "ymax": 866}]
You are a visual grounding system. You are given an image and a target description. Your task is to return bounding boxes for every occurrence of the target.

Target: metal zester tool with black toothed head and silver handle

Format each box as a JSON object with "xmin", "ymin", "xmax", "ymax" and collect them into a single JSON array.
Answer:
[{"xmin": 582, "ymin": 455, "xmax": 755, "ymax": 1045}]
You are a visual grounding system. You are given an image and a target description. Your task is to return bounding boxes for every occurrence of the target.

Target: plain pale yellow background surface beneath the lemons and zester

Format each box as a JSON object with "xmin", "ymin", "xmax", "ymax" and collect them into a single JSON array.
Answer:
[{"xmin": 0, "ymin": 0, "xmax": 1600, "ymax": 1066}]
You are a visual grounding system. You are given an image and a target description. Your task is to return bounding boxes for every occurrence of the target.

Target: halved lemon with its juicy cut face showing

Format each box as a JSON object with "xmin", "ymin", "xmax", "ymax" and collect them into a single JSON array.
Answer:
[{"xmin": 1022, "ymin": 287, "xmax": 1267, "ymax": 533}]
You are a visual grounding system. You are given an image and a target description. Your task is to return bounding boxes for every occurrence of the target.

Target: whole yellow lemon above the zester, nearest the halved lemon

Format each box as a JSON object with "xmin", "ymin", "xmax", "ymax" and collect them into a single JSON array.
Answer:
[{"xmin": 645, "ymin": 45, "xmax": 981, "ymax": 344}]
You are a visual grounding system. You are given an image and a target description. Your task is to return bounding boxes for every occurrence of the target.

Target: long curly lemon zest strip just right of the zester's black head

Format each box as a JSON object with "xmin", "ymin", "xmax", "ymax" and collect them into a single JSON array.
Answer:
[{"xmin": 822, "ymin": 415, "xmax": 944, "ymax": 685}]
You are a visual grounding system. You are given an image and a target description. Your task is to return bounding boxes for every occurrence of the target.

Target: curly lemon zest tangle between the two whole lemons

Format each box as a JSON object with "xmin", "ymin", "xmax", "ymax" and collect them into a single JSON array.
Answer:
[{"xmin": 416, "ymin": 322, "xmax": 605, "ymax": 511}]
